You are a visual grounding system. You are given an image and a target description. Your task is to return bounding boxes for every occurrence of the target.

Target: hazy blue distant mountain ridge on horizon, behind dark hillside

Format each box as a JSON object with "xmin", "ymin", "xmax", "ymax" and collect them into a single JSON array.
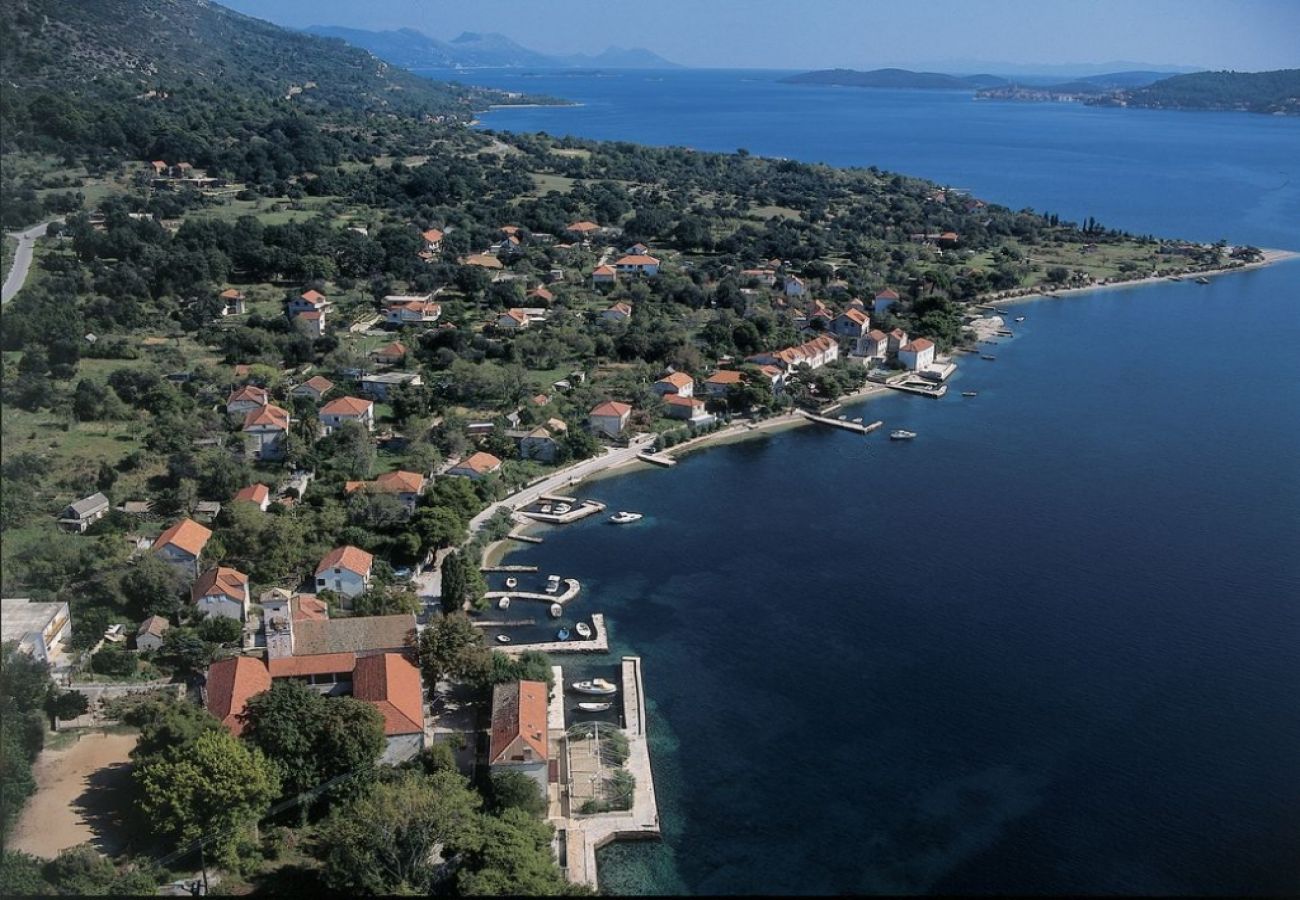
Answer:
[{"xmin": 307, "ymin": 25, "xmax": 676, "ymax": 69}]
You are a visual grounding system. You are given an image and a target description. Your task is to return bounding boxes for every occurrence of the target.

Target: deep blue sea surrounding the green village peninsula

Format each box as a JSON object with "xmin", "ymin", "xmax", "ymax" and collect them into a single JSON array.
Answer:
[{"xmin": 436, "ymin": 70, "xmax": 1300, "ymax": 895}]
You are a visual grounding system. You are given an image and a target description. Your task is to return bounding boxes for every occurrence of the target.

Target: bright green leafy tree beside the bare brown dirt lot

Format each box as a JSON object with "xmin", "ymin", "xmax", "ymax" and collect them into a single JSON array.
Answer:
[{"xmin": 131, "ymin": 728, "xmax": 280, "ymax": 866}]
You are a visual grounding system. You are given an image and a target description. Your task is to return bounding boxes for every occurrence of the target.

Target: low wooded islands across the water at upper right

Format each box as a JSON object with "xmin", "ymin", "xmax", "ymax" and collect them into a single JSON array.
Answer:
[{"xmin": 781, "ymin": 69, "xmax": 1300, "ymax": 116}]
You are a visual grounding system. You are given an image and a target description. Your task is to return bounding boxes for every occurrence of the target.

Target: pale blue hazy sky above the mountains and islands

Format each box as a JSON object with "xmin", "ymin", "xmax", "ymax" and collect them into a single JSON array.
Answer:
[{"xmin": 218, "ymin": 0, "xmax": 1300, "ymax": 72}]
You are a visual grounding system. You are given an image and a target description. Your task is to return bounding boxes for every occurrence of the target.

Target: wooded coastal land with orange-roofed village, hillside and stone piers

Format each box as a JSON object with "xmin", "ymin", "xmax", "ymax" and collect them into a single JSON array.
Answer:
[{"xmin": 0, "ymin": 0, "xmax": 1289, "ymax": 895}]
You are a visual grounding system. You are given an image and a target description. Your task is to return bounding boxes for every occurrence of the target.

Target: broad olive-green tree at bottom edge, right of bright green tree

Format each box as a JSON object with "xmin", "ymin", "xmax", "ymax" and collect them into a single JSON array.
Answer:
[{"xmin": 317, "ymin": 771, "xmax": 481, "ymax": 895}]
